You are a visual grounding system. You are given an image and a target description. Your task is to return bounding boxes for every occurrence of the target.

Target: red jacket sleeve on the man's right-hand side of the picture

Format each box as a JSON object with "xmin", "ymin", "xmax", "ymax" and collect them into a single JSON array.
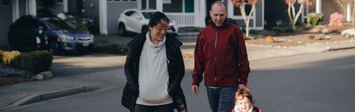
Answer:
[{"xmin": 234, "ymin": 27, "xmax": 250, "ymax": 85}]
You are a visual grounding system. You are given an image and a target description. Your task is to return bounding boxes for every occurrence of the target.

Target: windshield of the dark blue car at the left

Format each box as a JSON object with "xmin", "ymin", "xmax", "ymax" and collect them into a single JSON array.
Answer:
[{"xmin": 44, "ymin": 19, "xmax": 76, "ymax": 30}]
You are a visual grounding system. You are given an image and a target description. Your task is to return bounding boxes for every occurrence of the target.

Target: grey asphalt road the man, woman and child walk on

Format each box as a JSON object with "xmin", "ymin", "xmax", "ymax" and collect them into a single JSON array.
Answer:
[{"xmin": 4, "ymin": 49, "xmax": 355, "ymax": 112}]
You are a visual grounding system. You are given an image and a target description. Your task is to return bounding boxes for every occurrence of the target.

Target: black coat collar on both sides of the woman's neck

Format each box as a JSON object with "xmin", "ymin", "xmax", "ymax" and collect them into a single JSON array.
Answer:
[{"xmin": 127, "ymin": 31, "xmax": 182, "ymax": 50}]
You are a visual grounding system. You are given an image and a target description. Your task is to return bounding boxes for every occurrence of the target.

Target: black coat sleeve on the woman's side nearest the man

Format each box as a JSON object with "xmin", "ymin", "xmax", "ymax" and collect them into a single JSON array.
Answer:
[{"xmin": 168, "ymin": 49, "xmax": 185, "ymax": 95}]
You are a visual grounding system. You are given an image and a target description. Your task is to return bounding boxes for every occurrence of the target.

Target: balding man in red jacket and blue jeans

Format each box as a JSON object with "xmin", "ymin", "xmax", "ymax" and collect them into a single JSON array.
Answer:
[{"xmin": 191, "ymin": 1, "xmax": 250, "ymax": 112}]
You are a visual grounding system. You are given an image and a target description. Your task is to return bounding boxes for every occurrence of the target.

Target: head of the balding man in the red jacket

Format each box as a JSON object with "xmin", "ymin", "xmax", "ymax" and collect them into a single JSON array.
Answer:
[{"xmin": 210, "ymin": 1, "xmax": 227, "ymax": 27}]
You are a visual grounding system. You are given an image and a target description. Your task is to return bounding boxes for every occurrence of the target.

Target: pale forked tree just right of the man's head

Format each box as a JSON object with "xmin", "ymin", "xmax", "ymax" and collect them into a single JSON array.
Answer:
[{"xmin": 230, "ymin": 0, "xmax": 261, "ymax": 37}]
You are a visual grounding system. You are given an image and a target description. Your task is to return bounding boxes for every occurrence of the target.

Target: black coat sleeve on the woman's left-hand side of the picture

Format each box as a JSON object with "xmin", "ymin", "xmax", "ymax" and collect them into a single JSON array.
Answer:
[{"xmin": 124, "ymin": 49, "xmax": 139, "ymax": 95}]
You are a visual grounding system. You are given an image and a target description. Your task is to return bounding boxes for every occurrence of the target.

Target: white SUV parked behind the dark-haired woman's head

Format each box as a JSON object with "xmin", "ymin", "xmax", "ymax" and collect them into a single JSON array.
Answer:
[{"xmin": 117, "ymin": 9, "xmax": 179, "ymax": 35}]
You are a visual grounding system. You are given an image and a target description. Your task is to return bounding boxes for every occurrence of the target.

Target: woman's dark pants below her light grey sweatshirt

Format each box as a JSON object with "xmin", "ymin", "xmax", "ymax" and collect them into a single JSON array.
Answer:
[{"xmin": 135, "ymin": 103, "xmax": 174, "ymax": 112}]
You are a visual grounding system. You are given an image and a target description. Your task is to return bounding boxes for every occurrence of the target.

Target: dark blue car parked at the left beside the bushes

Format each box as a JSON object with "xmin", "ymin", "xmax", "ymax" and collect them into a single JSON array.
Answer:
[{"xmin": 7, "ymin": 16, "xmax": 94, "ymax": 54}]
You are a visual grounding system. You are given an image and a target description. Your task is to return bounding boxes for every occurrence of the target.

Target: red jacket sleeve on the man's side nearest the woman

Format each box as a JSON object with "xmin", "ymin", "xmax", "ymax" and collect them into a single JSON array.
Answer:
[{"xmin": 192, "ymin": 31, "xmax": 205, "ymax": 86}]
